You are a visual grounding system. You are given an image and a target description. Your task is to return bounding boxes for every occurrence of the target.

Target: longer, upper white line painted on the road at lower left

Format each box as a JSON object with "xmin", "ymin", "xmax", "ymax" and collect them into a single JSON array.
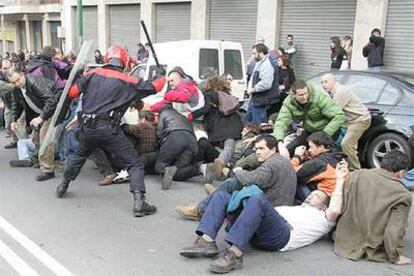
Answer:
[{"xmin": 0, "ymin": 216, "xmax": 73, "ymax": 276}]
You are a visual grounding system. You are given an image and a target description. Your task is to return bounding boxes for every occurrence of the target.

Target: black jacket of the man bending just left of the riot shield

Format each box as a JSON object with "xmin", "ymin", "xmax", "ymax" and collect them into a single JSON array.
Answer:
[{"xmin": 12, "ymin": 75, "xmax": 59, "ymax": 122}]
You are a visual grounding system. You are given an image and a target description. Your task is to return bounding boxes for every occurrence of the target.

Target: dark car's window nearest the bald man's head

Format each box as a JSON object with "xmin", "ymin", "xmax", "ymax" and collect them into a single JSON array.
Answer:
[{"xmin": 346, "ymin": 75, "xmax": 387, "ymax": 104}]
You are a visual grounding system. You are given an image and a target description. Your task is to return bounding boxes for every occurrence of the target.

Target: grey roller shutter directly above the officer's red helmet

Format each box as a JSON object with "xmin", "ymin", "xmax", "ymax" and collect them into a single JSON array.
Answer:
[{"xmin": 109, "ymin": 5, "xmax": 141, "ymax": 54}]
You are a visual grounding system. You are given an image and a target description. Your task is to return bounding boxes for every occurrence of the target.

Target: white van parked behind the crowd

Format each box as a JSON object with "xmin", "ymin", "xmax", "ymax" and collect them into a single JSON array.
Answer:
[{"xmin": 130, "ymin": 40, "xmax": 246, "ymax": 101}]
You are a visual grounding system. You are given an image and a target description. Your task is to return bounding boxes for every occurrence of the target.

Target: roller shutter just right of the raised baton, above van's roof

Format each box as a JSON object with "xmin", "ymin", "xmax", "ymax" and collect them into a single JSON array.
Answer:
[{"xmin": 155, "ymin": 2, "xmax": 191, "ymax": 42}]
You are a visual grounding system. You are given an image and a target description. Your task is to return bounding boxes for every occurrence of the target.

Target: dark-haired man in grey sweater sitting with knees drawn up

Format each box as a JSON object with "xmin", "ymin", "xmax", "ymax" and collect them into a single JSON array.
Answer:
[{"xmin": 176, "ymin": 134, "xmax": 296, "ymax": 220}]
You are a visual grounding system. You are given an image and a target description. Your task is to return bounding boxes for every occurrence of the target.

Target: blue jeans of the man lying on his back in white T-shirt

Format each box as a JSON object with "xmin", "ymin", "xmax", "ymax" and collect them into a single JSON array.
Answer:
[{"xmin": 196, "ymin": 191, "xmax": 290, "ymax": 251}]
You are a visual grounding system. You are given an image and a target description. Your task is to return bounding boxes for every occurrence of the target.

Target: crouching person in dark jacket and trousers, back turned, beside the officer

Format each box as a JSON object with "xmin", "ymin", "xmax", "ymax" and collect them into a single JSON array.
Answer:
[{"xmin": 154, "ymin": 108, "xmax": 198, "ymax": 190}]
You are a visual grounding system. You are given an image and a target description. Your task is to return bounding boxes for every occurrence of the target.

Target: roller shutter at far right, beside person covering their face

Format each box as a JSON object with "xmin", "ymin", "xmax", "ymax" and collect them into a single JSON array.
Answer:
[{"xmin": 384, "ymin": 0, "xmax": 414, "ymax": 72}]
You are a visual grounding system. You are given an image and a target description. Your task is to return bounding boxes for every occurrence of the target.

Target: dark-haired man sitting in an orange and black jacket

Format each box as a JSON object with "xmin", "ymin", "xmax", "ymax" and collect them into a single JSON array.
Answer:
[{"xmin": 292, "ymin": 131, "xmax": 346, "ymax": 202}]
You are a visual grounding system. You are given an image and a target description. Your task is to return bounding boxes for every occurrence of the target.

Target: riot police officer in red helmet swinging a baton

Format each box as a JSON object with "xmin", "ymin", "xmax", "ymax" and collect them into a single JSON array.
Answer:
[{"xmin": 56, "ymin": 45, "xmax": 166, "ymax": 217}]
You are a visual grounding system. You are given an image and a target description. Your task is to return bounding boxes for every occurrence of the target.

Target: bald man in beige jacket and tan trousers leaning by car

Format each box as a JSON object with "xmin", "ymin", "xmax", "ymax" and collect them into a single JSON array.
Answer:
[{"xmin": 322, "ymin": 73, "xmax": 371, "ymax": 170}]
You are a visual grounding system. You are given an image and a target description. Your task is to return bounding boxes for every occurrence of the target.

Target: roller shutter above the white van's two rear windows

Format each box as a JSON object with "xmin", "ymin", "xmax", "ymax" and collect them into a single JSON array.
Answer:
[{"xmin": 209, "ymin": 0, "xmax": 257, "ymax": 60}]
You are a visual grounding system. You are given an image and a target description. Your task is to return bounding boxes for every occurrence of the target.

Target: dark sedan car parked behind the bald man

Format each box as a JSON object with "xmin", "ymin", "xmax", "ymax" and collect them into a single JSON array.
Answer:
[{"xmin": 308, "ymin": 70, "xmax": 414, "ymax": 168}]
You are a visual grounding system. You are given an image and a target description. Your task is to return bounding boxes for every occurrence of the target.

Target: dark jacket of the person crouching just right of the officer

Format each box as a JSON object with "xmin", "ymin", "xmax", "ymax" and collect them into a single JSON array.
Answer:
[{"xmin": 157, "ymin": 108, "xmax": 194, "ymax": 141}]
